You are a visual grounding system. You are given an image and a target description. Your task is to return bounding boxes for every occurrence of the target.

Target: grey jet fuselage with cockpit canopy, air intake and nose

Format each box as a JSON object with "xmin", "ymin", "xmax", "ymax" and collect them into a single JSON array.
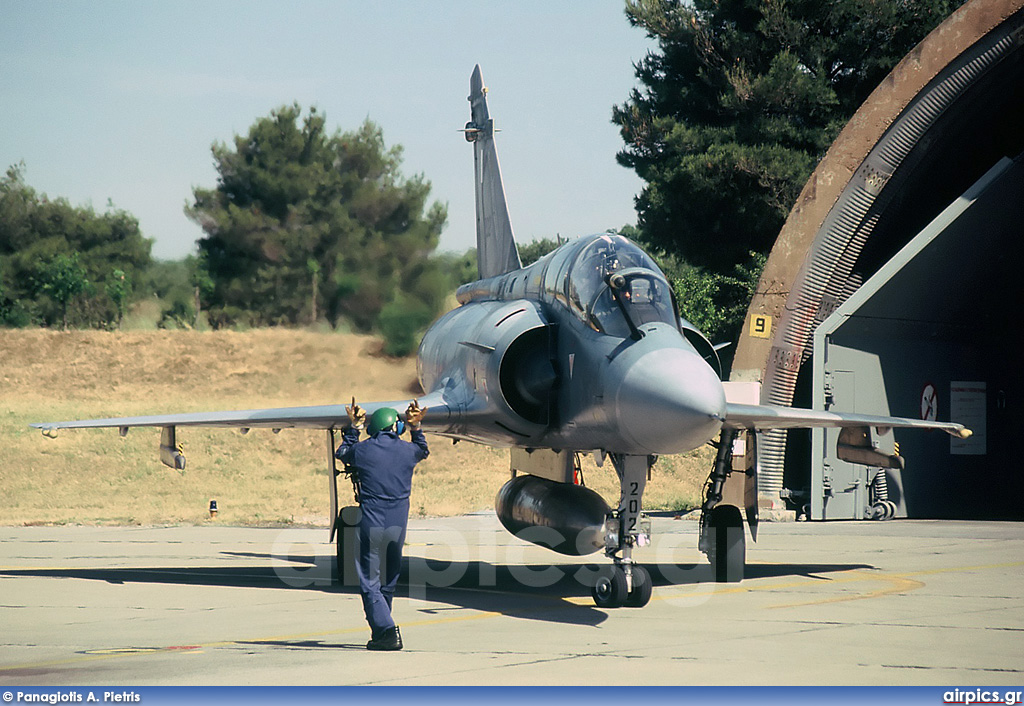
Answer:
[{"xmin": 419, "ymin": 229, "xmax": 725, "ymax": 455}]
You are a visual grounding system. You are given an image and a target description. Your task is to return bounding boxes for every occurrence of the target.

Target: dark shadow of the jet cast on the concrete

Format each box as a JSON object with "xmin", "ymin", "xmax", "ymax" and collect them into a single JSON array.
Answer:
[{"xmin": 0, "ymin": 552, "xmax": 872, "ymax": 627}]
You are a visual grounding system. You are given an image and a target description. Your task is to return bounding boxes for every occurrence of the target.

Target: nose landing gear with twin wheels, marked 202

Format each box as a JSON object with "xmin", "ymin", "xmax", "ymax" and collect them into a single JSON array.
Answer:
[{"xmin": 591, "ymin": 454, "xmax": 655, "ymax": 608}]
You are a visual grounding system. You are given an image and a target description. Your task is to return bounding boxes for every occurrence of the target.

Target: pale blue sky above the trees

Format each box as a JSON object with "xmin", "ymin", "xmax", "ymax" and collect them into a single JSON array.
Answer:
[{"xmin": 0, "ymin": 0, "xmax": 653, "ymax": 258}]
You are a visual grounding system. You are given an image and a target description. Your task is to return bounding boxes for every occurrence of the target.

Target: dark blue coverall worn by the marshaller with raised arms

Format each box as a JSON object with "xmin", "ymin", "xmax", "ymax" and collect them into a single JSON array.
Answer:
[{"xmin": 335, "ymin": 427, "xmax": 430, "ymax": 638}]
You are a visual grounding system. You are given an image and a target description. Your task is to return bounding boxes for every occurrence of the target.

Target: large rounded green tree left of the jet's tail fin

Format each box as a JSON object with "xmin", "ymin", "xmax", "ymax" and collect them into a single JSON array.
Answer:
[{"xmin": 186, "ymin": 105, "xmax": 446, "ymax": 330}]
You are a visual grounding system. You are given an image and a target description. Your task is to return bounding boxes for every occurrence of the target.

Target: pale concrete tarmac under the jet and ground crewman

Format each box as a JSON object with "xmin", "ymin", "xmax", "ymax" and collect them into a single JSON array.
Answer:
[{"xmin": 0, "ymin": 514, "xmax": 1024, "ymax": 687}]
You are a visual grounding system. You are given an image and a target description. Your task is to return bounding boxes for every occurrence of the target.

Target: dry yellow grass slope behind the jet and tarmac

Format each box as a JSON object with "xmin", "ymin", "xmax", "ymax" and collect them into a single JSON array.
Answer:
[{"xmin": 0, "ymin": 329, "xmax": 711, "ymax": 526}]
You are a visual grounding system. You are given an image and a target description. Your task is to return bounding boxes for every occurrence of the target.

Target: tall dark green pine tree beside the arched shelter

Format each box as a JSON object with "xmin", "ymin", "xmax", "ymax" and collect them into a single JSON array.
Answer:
[{"xmin": 612, "ymin": 0, "xmax": 958, "ymax": 276}]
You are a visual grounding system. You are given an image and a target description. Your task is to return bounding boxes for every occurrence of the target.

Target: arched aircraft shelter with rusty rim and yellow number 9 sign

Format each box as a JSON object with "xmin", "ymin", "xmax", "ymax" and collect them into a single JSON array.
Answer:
[{"xmin": 731, "ymin": 0, "xmax": 1024, "ymax": 520}]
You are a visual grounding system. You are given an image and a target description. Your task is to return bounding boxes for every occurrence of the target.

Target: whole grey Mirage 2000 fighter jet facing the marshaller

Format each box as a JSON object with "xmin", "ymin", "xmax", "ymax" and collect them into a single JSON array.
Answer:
[{"xmin": 34, "ymin": 67, "xmax": 970, "ymax": 608}]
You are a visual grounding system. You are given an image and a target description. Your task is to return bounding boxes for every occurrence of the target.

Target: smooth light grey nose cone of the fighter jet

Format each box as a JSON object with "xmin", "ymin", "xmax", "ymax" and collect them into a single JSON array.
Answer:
[{"xmin": 615, "ymin": 347, "xmax": 725, "ymax": 454}]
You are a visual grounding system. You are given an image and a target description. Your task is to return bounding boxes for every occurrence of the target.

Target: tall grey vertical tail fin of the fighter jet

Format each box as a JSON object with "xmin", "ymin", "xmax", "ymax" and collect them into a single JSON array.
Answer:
[{"xmin": 466, "ymin": 65, "xmax": 522, "ymax": 279}]
